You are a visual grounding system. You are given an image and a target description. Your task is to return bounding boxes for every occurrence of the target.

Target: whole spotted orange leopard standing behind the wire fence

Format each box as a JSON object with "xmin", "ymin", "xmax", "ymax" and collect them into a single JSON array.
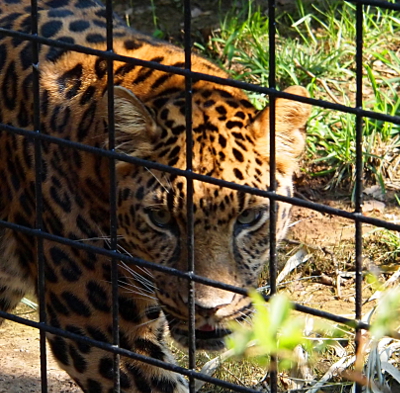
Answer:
[{"xmin": 0, "ymin": 0, "xmax": 310, "ymax": 393}]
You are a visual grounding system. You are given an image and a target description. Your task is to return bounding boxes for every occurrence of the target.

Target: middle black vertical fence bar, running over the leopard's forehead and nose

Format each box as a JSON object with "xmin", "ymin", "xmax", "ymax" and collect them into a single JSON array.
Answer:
[{"xmin": 184, "ymin": 0, "xmax": 196, "ymax": 393}]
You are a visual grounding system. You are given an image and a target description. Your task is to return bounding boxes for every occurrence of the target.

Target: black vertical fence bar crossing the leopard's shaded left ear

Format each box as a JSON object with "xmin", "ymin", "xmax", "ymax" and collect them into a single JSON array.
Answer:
[{"xmin": 106, "ymin": 0, "xmax": 121, "ymax": 393}]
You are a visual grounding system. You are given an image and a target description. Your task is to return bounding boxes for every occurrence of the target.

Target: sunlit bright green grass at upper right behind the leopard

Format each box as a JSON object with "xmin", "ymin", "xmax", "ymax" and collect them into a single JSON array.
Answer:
[{"xmin": 202, "ymin": 0, "xmax": 400, "ymax": 196}]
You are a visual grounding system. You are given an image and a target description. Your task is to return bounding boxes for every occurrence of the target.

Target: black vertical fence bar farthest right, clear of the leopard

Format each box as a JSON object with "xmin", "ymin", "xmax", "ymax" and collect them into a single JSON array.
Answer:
[{"xmin": 355, "ymin": 2, "xmax": 364, "ymax": 393}]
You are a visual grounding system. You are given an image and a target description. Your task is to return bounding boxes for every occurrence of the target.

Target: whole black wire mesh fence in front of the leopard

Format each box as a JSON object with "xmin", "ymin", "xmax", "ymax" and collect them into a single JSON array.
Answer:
[{"xmin": 0, "ymin": 0, "xmax": 400, "ymax": 392}]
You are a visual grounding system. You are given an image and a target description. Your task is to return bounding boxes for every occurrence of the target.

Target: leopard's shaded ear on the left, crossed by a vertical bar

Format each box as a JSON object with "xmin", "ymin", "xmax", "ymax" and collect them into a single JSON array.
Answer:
[{"xmin": 101, "ymin": 86, "xmax": 159, "ymax": 157}]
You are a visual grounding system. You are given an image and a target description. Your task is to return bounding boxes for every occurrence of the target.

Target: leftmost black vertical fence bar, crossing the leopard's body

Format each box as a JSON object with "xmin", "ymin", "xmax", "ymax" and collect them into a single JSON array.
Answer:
[{"xmin": 31, "ymin": 0, "xmax": 47, "ymax": 393}]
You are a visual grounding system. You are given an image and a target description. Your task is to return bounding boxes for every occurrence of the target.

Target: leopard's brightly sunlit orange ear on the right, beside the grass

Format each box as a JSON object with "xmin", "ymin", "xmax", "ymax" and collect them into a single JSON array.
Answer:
[{"xmin": 250, "ymin": 86, "xmax": 311, "ymax": 171}]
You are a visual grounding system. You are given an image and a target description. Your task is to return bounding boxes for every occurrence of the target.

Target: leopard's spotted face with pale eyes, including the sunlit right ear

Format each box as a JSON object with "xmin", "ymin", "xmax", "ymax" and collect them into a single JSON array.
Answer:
[{"xmin": 111, "ymin": 84, "xmax": 309, "ymax": 349}]
